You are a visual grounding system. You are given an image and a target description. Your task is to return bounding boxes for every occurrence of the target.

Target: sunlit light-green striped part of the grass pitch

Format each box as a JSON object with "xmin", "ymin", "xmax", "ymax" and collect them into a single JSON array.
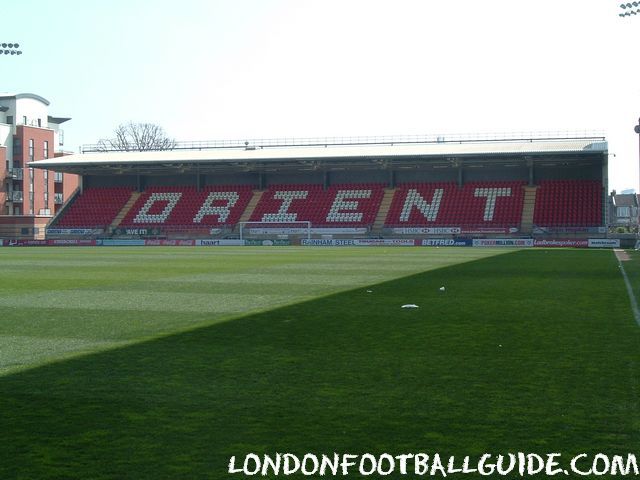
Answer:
[{"xmin": 0, "ymin": 247, "xmax": 502, "ymax": 373}]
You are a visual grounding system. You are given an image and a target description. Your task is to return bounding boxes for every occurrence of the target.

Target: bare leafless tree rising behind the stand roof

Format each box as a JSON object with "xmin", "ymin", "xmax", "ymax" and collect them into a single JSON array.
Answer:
[{"xmin": 98, "ymin": 122, "xmax": 176, "ymax": 152}]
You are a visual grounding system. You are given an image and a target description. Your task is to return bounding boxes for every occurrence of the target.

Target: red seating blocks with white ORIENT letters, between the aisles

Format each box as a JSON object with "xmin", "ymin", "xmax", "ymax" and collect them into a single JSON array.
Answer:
[{"xmin": 47, "ymin": 180, "xmax": 602, "ymax": 233}]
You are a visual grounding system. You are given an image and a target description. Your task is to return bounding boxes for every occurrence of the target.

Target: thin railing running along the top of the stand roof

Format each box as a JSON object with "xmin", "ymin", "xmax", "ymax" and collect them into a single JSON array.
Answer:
[{"xmin": 80, "ymin": 130, "xmax": 606, "ymax": 153}]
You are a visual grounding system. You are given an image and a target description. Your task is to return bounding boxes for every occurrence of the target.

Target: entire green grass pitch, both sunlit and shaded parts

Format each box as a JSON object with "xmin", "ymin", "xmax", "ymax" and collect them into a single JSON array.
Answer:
[{"xmin": 0, "ymin": 247, "xmax": 640, "ymax": 480}]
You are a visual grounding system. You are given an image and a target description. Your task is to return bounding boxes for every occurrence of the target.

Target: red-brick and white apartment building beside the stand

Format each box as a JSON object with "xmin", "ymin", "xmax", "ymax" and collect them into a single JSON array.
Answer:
[{"xmin": 0, "ymin": 93, "xmax": 78, "ymax": 238}]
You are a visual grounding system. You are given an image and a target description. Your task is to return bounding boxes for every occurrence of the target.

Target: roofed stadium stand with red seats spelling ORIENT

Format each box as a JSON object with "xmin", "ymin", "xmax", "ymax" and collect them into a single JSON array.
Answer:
[{"xmin": 26, "ymin": 136, "xmax": 608, "ymax": 239}]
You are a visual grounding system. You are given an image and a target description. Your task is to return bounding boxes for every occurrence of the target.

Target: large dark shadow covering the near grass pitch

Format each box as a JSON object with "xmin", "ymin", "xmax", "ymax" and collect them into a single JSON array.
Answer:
[{"xmin": 0, "ymin": 250, "xmax": 640, "ymax": 480}]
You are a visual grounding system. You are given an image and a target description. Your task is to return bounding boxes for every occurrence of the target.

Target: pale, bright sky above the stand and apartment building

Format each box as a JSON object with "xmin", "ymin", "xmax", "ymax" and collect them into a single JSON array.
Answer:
[{"xmin": 0, "ymin": 0, "xmax": 640, "ymax": 190}]
